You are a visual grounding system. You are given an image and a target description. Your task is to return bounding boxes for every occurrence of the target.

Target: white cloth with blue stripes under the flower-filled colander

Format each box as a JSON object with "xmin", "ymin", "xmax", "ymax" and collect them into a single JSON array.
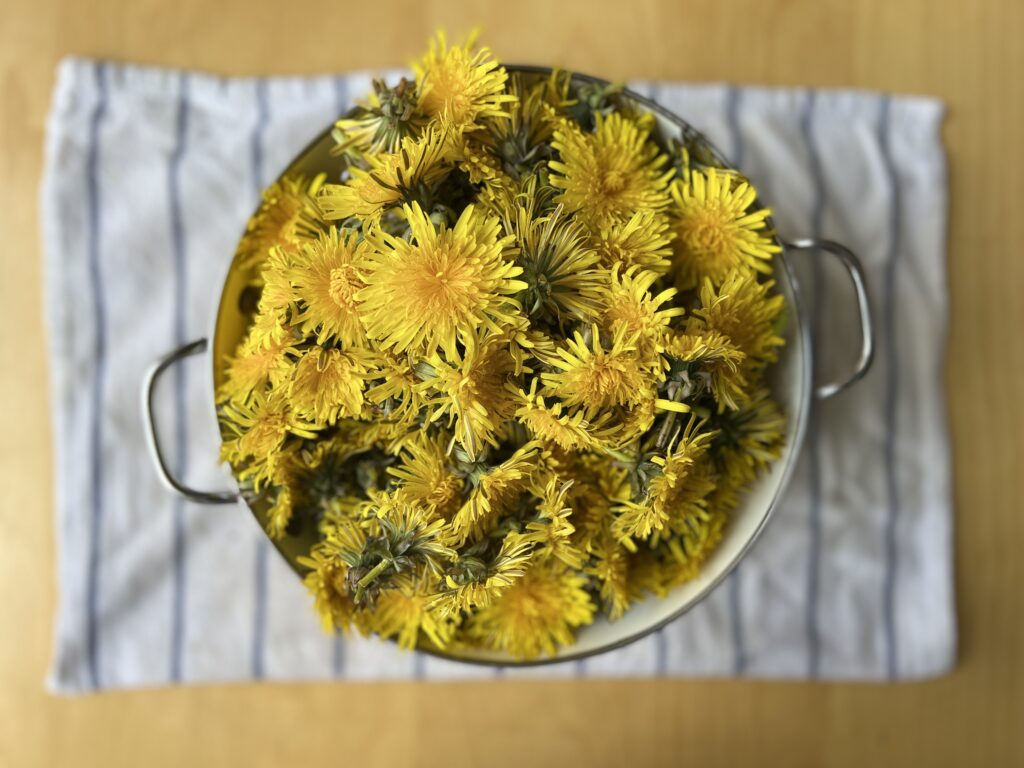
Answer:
[{"xmin": 42, "ymin": 59, "xmax": 955, "ymax": 692}]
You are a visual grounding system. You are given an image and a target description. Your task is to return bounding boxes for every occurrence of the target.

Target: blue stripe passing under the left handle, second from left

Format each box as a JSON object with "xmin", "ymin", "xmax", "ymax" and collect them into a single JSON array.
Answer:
[{"xmin": 167, "ymin": 74, "xmax": 188, "ymax": 682}]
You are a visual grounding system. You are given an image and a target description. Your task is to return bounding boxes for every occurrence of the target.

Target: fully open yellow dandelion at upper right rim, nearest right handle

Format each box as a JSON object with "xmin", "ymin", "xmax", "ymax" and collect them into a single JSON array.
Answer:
[{"xmin": 672, "ymin": 168, "xmax": 779, "ymax": 290}]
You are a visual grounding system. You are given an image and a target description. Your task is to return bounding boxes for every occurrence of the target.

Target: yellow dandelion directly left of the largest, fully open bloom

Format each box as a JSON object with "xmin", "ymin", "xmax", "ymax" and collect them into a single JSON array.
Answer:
[{"xmin": 289, "ymin": 226, "xmax": 367, "ymax": 346}]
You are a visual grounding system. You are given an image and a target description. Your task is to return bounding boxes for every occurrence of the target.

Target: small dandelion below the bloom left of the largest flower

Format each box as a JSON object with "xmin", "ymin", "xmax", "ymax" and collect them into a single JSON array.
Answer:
[{"xmin": 288, "ymin": 346, "xmax": 368, "ymax": 424}]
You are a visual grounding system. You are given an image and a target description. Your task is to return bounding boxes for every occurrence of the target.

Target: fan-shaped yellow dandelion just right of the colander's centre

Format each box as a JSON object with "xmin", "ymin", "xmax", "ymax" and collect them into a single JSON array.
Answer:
[{"xmin": 541, "ymin": 326, "xmax": 658, "ymax": 418}]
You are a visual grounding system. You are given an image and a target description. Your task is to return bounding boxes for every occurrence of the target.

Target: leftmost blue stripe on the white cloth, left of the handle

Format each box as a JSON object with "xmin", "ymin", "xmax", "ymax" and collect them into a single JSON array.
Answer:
[{"xmin": 85, "ymin": 62, "xmax": 108, "ymax": 689}]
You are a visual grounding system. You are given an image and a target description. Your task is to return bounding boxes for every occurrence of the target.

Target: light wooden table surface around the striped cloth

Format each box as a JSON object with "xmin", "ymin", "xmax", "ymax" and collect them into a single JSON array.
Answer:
[{"xmin": 0, "ymin": 0, "xmax": 1024, "ymax": 766}]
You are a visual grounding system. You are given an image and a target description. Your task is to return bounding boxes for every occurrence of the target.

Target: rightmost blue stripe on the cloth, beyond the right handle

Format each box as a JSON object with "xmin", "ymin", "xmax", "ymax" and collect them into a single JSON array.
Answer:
[{"xmin": 879, "ymin": 96, "xmax": 902, "ymax": 679}]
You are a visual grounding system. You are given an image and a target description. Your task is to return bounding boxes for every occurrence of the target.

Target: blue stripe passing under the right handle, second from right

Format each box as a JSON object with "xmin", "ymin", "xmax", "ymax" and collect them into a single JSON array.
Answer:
[{"xmin": 800, "ymin": 91, "xmax": 826, "ymax": 678}]
